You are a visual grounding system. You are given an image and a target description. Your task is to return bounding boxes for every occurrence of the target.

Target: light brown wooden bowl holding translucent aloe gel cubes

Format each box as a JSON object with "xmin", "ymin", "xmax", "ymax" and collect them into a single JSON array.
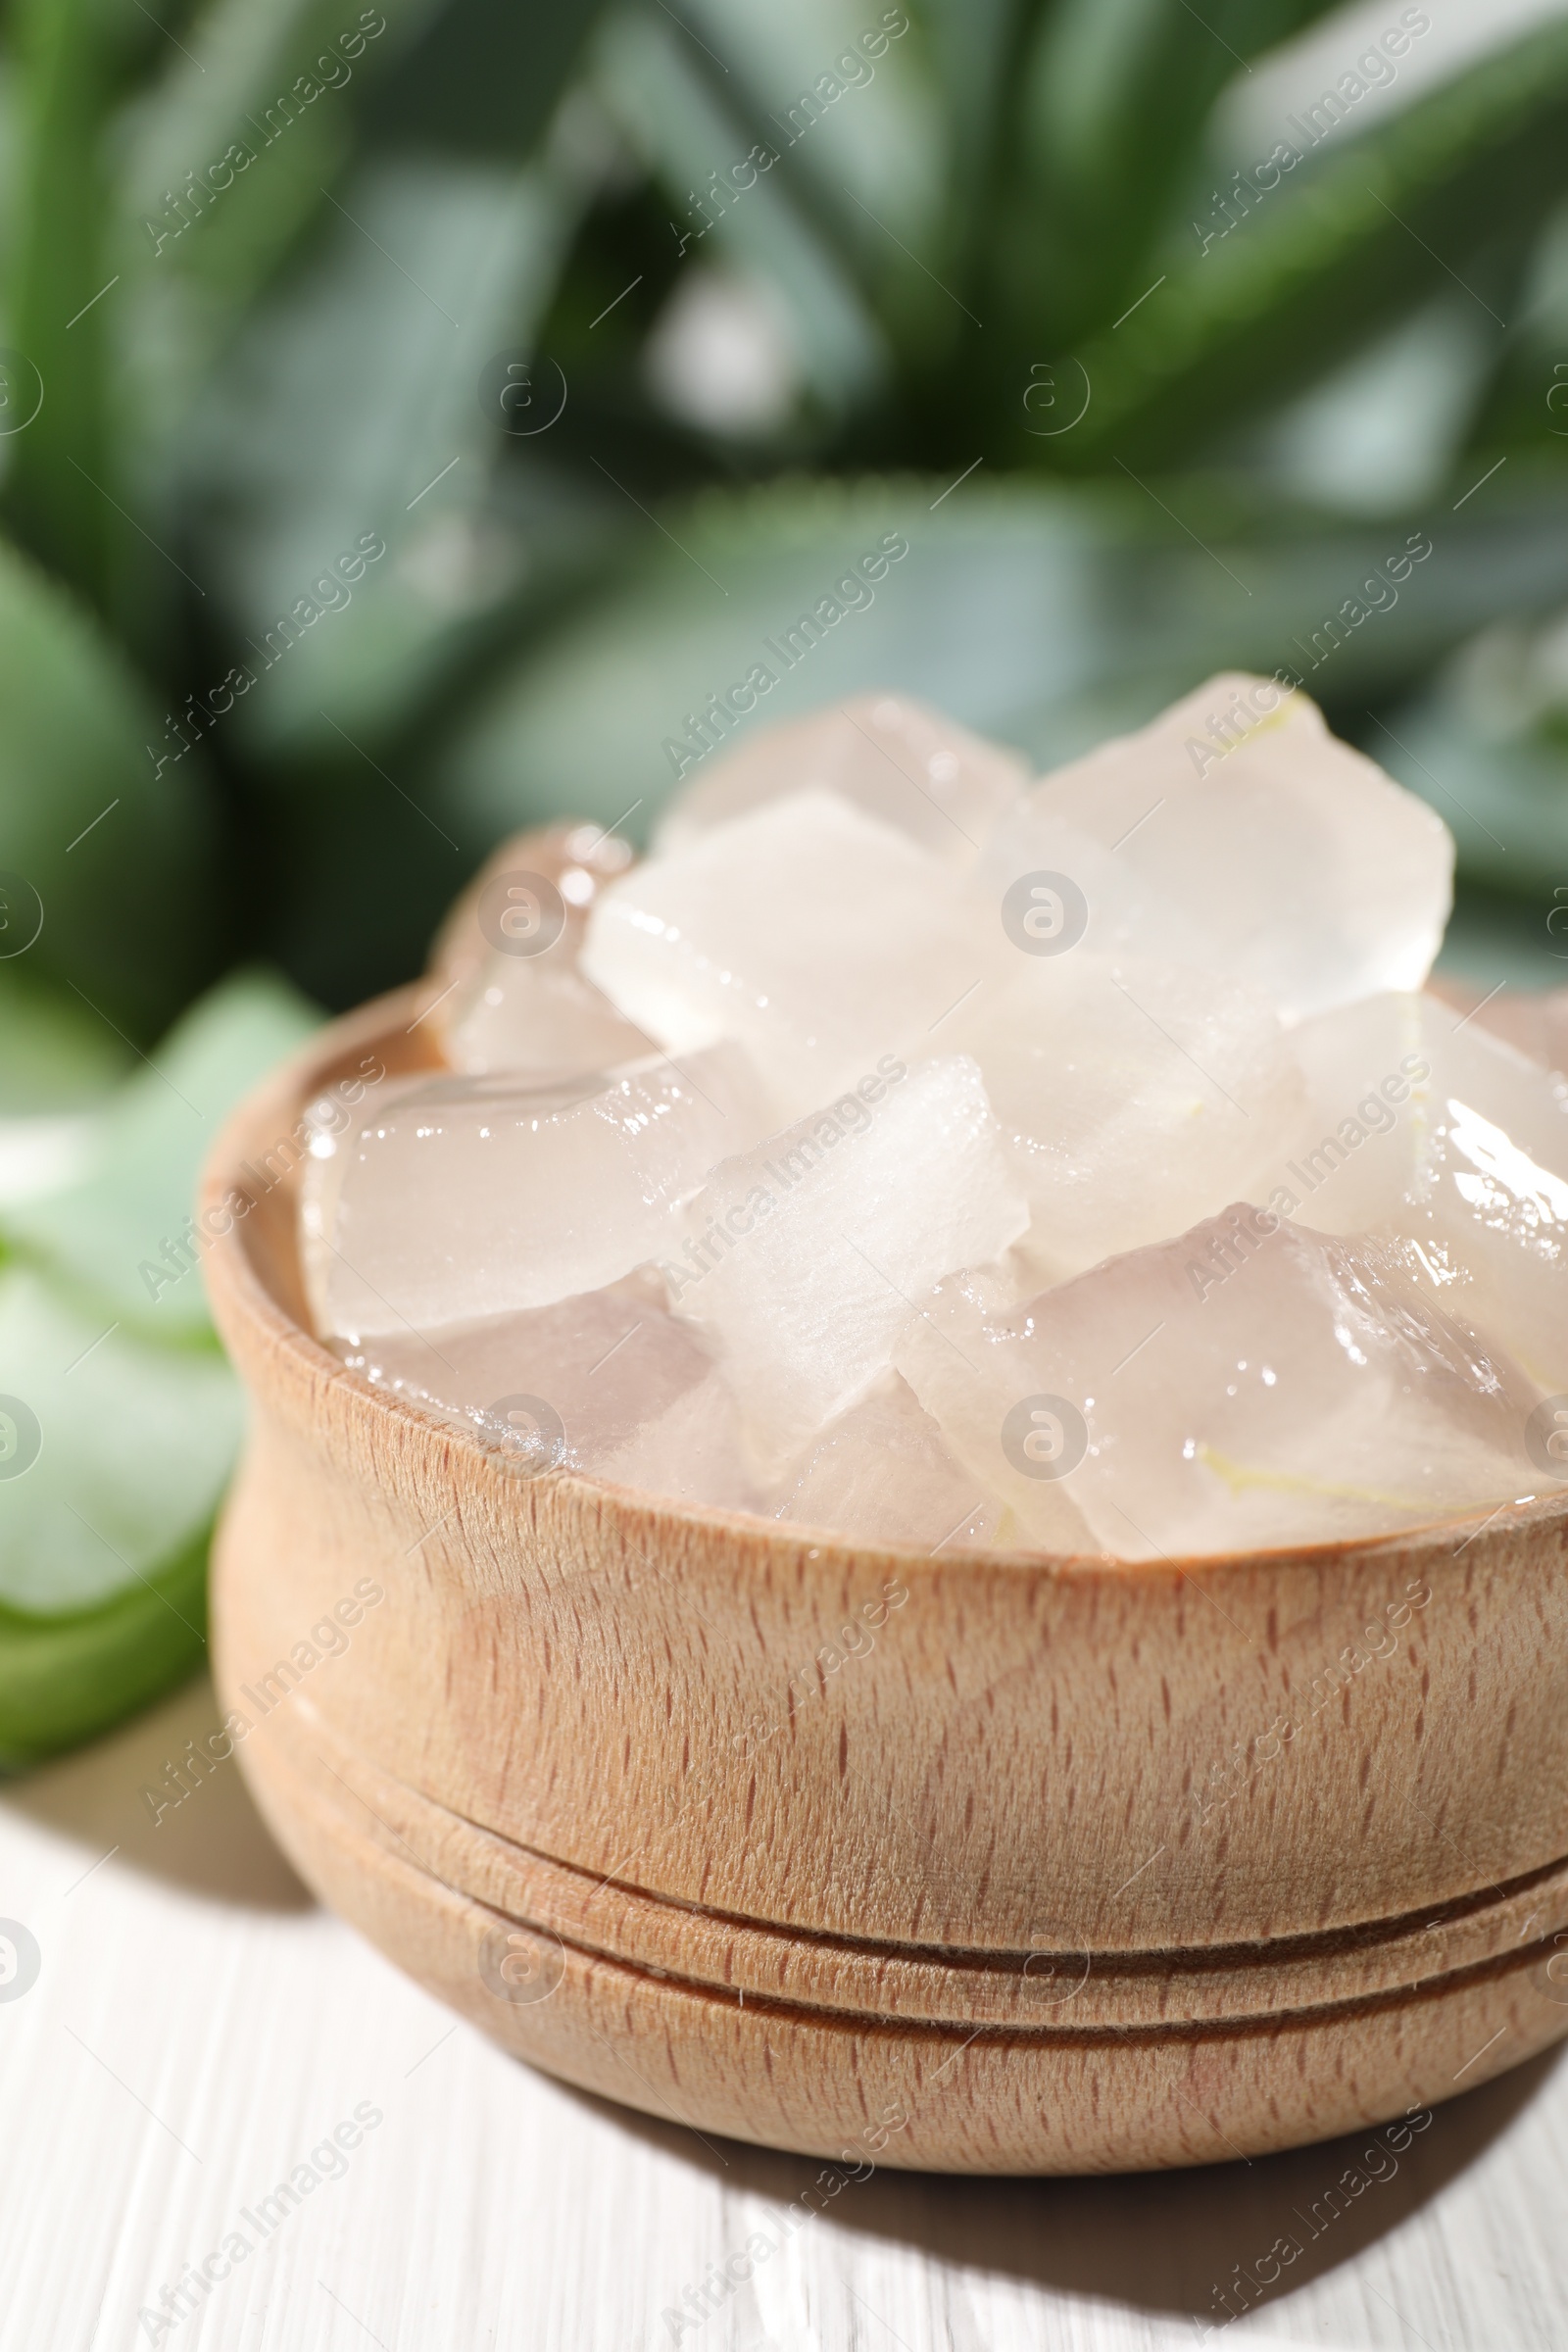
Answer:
[{"xmin": 205, "ymin": 986, "xmax": 1568, "ymax": 2174}]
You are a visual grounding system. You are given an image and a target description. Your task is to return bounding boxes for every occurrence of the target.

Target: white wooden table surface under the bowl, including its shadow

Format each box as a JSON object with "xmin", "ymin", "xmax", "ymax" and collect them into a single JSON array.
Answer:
[{"xmin": 0, "ymin": 1682, "xmax": 1568, "ymax": 2352}]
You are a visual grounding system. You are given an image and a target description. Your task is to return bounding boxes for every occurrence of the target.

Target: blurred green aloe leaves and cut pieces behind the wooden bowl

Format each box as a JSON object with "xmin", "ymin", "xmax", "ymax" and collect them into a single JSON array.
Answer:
[{"xmin": 0, "ymin": 0, "xmax": 1568, "ymax": 1762}]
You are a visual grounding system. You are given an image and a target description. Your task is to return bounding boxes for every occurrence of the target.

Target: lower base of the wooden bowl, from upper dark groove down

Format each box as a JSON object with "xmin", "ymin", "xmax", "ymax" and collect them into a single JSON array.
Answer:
[{"xmin": 240, "ymin": 1705, "xmax": 1568, "ymax": 2174}]
